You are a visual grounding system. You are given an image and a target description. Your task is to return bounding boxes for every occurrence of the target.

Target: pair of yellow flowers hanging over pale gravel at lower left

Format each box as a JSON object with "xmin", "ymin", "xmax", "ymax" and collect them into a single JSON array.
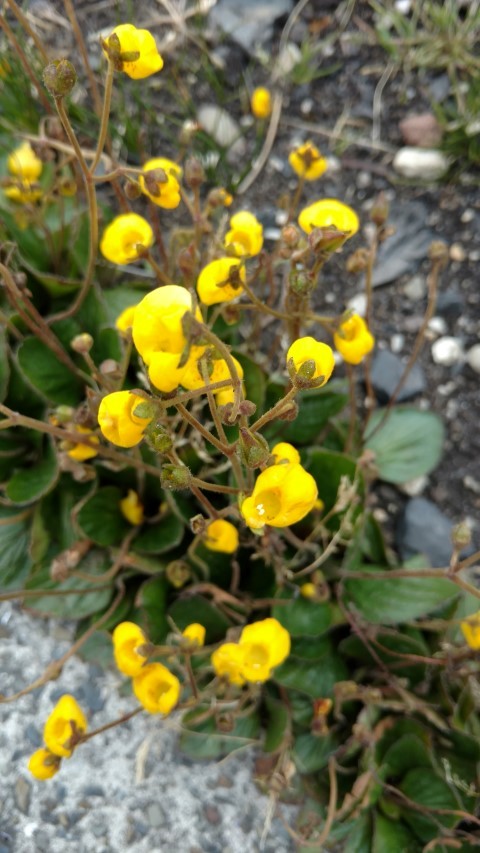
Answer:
[{"xmin": 28, "ymin": 693, "xmax": 87, "ymax": 781}]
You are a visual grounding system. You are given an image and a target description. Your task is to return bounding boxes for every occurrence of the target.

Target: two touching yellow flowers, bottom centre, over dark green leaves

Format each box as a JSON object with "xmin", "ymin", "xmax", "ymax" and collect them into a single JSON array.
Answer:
[{"xmin": 212, "ymin": 618, "xmax": 290, "ymax": 687}]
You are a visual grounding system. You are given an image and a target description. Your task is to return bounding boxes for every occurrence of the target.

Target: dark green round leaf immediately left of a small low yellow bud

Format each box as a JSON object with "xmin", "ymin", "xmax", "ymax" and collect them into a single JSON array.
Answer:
[{"xmin": 77, "ymin": 486, "xmax": 129, "ymax": 547}]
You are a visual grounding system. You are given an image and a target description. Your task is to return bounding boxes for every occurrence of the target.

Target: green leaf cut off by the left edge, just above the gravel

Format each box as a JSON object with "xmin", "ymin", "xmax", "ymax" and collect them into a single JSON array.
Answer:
[{"xmin": 0, "ymin": 506, "xmax": 32, "ymax": 591}]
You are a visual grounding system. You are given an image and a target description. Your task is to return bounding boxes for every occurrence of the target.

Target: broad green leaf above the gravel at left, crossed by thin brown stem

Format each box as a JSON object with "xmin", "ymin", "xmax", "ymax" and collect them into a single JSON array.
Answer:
[{"xmin": 25, "ymin": 551, "xmax": 113, "ymax": 620}]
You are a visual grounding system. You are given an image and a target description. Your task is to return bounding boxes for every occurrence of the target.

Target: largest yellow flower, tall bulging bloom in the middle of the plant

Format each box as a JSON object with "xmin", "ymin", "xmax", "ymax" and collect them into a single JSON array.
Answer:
[{"xmin": 133, "ymin": 284, "xmax": 203, "ymax": 392}]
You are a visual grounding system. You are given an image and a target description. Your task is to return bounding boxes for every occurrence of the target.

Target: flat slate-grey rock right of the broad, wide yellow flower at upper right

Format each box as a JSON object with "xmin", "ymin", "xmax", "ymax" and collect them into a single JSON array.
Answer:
[{"xmin": 373, "ymin": 201, "xmax": 433, "ymax": 287}]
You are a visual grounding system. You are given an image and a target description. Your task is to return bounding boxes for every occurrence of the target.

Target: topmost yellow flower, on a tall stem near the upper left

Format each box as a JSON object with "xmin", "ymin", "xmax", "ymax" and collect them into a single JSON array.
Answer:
[{"xmin": 104, "ymin": 24, "xmax": 163, "ymax": 80}]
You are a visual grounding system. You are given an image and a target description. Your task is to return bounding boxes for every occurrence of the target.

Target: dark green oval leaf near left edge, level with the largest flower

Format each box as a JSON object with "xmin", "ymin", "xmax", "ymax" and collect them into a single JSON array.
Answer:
[{"xmin": 18, "ymin": 338, "xmax": 84, "ymax": 406}]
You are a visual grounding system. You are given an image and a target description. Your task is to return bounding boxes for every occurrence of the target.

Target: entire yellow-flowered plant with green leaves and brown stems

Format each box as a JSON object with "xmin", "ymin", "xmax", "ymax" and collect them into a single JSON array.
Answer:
[{"xmin": 0, "ymin": 8, "xmax": 480, "ymax": 851}]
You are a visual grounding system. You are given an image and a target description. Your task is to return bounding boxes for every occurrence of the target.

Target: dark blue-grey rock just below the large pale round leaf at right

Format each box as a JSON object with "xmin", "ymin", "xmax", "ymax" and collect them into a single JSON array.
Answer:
[{"xmin": 397, "ymin": 498, "xmax": 474, "ymax": 568}]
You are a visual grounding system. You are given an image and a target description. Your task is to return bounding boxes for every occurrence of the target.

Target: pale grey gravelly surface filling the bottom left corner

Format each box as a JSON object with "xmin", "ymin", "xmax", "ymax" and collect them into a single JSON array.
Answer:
[{"xmin": 0, "ymin": 604, "xmax": 294, "ymax": 853}]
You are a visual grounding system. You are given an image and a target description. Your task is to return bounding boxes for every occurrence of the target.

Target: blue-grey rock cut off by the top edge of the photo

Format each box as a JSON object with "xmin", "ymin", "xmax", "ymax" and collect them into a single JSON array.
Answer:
[{"xmin": 209, "ymin": 0, "xmax": 294, "ymax": 53}]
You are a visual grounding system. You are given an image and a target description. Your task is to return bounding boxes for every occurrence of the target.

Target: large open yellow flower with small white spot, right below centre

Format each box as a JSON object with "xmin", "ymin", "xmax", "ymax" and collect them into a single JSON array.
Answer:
[{"xmin": 240, "ymin": 463, "xmax": 318, "ymax": 530}]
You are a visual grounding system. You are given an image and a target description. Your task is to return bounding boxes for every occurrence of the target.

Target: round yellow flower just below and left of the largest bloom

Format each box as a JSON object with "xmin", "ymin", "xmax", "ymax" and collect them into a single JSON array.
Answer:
[{"xmin": 98, "ymin": 391, "xmax": 152, "ymax": 447}]
